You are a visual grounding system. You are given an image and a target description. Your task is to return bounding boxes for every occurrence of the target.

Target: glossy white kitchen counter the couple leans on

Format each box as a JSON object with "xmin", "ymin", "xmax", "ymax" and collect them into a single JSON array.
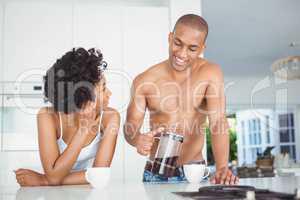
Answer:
[{"xmin": 0, "ymin": 177, "xmax": 300, "ymax": 200}]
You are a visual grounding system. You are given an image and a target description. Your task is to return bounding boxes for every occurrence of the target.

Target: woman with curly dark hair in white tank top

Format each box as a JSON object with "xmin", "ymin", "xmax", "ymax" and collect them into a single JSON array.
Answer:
[{"xmin": 15, "ymin": 48, "xmax": 120, "ymax": 186}]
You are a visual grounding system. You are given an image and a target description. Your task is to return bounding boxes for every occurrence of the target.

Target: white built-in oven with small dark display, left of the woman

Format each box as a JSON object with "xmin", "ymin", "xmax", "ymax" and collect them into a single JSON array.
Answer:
[{"xmin": 1, "ymin": 83, "xmax": 47, "ymax": 151}]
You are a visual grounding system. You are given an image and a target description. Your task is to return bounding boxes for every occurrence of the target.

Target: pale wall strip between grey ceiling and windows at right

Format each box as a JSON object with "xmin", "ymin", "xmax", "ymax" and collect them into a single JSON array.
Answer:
[{"xmin": 225, "ymin": 75, "xmax": 300, "ymax": 108}]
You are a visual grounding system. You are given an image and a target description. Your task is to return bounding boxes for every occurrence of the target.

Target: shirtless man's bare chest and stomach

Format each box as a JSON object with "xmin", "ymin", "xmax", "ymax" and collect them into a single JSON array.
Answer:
[{"xmin": 140, "ymin": 58, "xmax": 213, "ymax": 164}]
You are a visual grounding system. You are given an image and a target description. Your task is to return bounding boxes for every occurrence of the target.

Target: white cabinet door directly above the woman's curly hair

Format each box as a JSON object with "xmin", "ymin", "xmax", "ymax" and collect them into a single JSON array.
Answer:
[{"xmin": 73, "ymin": 2, "xmax": 123, "ymax": 70}]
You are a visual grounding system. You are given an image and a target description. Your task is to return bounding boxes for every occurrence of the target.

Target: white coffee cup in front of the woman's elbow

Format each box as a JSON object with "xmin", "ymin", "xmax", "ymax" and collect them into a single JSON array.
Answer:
[{"xmin": 85, "ymin": 167, "xmax": 110, "ymax": 189}]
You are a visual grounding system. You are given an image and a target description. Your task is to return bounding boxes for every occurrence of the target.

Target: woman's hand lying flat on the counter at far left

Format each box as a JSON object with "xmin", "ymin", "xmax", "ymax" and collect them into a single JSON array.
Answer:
[{"xmin": 14, "ymin": 169, "xmax": 48, "ymax": 187}]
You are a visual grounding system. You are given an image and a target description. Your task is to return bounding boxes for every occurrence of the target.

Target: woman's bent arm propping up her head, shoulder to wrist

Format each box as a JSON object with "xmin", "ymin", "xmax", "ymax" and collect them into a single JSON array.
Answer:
[{"xmin": 37, "ymin": 108, "xmax": 95, "ymax": 185}]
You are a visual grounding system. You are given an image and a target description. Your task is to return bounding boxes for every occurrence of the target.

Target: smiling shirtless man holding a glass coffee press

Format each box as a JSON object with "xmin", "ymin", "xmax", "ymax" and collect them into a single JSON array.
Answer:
[{"xmin": 124, "ymin": 14, "xmax": 238, "ymax": 184}]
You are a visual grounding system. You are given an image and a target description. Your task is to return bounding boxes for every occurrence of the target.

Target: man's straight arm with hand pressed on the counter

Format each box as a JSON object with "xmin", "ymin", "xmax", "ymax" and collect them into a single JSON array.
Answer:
[{"xmin": 205, "ymin": 66, "xmax": 239, "ymax": 185}]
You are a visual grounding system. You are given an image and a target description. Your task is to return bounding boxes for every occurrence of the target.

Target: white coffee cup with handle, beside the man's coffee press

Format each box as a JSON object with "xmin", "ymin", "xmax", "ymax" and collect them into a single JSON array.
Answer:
[{"xmin": 183, "ymin": 164, "xmax": 210, "ymax": 183}]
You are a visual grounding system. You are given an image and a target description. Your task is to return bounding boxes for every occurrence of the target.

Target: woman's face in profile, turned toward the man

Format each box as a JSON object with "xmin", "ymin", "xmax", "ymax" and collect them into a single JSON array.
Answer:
[{"xmin": 95, "ymin": 76, "xmax": 112, "ymax": 110}]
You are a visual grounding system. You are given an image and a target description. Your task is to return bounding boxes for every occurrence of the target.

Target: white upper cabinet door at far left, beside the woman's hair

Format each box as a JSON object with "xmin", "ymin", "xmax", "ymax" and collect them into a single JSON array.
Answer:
[{"xmin": 3, "ymin": 1, "xmax": 72, "ymax": 81}]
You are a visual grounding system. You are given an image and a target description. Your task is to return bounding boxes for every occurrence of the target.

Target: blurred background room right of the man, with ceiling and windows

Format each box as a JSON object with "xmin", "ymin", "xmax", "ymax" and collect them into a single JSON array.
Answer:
[{"xmin": 201, "ymin": 0, "xmax": 300, "ymax": 176}]
